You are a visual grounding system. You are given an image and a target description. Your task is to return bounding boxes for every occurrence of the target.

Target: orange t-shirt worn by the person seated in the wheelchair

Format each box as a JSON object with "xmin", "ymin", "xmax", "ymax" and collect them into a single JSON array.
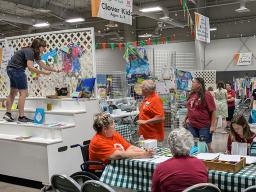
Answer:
[{"xmin": 89, "ymin": 132, "xmax": 131, "ymax": 163}]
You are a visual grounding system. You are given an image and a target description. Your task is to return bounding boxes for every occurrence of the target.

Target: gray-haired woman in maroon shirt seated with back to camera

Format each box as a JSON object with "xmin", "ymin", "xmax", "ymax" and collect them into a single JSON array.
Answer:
[{"xmin": 152, "ymin": 128, "xmax": 208, "ymax": 192}]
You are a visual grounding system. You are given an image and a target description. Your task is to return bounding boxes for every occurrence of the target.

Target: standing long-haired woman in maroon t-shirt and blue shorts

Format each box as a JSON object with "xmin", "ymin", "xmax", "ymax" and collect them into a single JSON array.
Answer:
[{"xmin": 184, "ymin": 77, "xmax": 216, "ymax": 152}]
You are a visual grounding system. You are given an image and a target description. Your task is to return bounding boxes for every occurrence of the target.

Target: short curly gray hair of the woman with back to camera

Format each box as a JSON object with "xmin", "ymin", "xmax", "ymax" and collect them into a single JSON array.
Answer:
[{"xmin": 168, "ymin": 128, "xmax": 194, "ymax": 156}]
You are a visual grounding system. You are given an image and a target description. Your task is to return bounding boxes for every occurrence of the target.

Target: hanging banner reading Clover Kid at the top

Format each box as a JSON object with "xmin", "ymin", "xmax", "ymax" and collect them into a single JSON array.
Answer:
[{"xmin": 91, "ymin": 0, "xmax": 133, "ymax": 25}]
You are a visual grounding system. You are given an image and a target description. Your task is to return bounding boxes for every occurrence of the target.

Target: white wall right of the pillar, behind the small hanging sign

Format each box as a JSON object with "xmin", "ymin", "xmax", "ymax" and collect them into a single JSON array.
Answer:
[{"xmin": 205, "ymin": 37, "xmax": 256, "ymax": 71}]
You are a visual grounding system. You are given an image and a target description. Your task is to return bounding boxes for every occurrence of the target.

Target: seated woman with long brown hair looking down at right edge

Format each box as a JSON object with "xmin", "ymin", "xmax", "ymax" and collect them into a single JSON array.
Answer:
[{"xmin": 227, "ymin": 115, "xmax": 256, "ymax": 154}]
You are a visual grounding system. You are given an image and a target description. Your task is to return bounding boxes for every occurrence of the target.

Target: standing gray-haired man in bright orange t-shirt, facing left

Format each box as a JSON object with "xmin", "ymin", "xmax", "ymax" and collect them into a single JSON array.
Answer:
[{"xmin": 137, "ymin": 80, "xmax": 164, "ymax": 141}]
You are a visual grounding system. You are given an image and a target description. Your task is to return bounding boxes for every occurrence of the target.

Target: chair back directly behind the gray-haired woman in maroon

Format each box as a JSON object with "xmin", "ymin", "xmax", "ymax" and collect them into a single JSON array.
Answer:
[{"xmin": 183, "ymin": 183, "xmax": 221, "ymax": 192}]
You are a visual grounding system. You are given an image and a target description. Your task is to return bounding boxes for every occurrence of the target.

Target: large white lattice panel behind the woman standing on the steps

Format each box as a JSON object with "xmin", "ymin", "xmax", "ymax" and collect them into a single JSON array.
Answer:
[{"xmin": 0, "ymin": 28, "xmax": 96, "ymax": 97}]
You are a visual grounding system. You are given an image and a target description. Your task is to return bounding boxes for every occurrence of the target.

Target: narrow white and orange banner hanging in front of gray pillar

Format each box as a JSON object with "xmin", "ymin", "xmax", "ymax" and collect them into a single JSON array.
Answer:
[{"xmin": 195, "ymin": 12, "xmax": 210, "ymax": 43}]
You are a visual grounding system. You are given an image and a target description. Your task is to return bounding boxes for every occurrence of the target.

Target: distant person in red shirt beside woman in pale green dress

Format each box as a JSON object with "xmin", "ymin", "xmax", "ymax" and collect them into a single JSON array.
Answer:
[{"xmin": 226, "ymin": 83, "xmax": 236, "ymax": 127}]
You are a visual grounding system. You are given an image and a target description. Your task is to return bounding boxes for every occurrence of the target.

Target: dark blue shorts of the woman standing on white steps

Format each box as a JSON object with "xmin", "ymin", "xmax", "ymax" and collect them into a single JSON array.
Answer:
[{"xmin": 7, "ymin": 67, "xmax": 28, "ymax": 90}]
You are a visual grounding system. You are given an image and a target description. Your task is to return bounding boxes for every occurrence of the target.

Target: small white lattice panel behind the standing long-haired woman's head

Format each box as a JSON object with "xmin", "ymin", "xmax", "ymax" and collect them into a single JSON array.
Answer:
[{"xmin": 191, "ymin": 70, "xmax": 216, "ymax": 89}]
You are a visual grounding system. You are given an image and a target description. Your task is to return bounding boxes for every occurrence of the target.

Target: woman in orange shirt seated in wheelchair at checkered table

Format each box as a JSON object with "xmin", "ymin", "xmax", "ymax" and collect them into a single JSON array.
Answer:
[{"xmin": 89, "ymin": 113, "xmax": 153, "ymax": 163}]
